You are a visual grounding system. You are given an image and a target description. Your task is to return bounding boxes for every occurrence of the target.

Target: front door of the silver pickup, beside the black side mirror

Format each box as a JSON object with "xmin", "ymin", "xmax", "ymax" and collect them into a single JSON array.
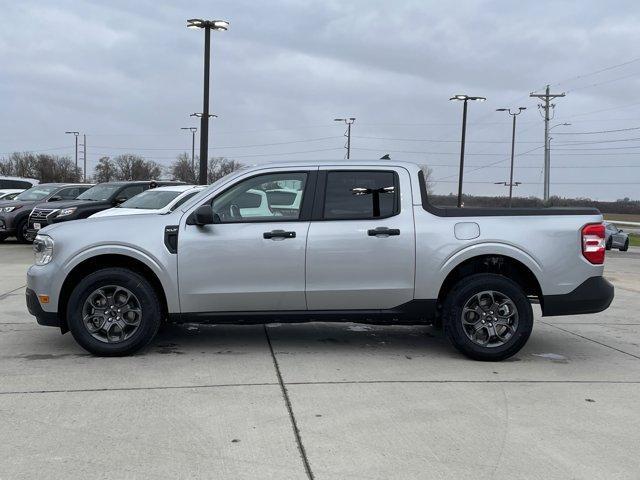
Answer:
[{"xmin": 178, "ymin": 170, "xmax": 316, "ymax": 313}]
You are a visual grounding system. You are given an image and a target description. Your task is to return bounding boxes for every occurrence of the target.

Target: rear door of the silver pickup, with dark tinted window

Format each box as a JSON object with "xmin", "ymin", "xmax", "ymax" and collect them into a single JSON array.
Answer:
[{"xmin": 306, "ymin": 167, "xmax": 415, "ymax": 310}]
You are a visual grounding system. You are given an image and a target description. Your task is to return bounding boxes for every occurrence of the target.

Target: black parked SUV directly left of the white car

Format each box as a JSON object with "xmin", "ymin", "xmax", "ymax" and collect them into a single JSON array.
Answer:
[{"xmin": 27, "ymin": 180, "xmax": 182, "ymax": 236}]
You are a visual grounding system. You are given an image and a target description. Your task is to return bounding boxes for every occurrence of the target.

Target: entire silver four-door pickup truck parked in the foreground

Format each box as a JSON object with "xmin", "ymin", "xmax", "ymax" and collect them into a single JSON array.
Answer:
[{"xmin": 26, "ymin": 161, "xmax": 613, "ymax": 360}]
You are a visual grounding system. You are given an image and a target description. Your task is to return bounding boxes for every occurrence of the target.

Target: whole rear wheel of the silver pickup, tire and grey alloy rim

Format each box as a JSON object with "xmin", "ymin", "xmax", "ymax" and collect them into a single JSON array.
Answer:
[{"xmin": 442, "ymin": 273, "xmax": 533, "ymax": 361}]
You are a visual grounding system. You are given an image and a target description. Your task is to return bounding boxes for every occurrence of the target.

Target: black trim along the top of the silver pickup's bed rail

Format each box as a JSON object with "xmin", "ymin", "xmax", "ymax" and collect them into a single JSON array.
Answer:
[{"xmin": 418, "ymin": 170, "xmax": 601, "ymax": 217}]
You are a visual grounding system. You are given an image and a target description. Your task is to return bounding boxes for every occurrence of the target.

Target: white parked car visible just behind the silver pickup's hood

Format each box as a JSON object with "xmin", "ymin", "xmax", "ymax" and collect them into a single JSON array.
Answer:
[{"xmin": 91, "ymin": 185, "xmax": 205, "ymax": 217}]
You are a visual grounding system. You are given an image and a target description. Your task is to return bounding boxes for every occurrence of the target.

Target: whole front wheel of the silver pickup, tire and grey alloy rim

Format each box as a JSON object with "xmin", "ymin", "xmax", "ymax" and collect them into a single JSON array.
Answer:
[{"xmin": 67, "ymin": 268, "xmax": 162, "ymax": 356}]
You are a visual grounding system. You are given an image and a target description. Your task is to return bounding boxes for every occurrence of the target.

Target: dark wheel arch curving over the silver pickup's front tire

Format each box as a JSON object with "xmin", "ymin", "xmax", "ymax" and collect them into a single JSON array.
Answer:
[{"xmin": 58, "ymin": 253, "xmax": 169, "ymax": 333}]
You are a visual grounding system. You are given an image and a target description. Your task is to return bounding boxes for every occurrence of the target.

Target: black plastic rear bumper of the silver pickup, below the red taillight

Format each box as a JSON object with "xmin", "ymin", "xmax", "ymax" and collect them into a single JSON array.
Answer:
[{"xmin": 542, "ymin": 276, "xmax": 614, "ymax": 317}]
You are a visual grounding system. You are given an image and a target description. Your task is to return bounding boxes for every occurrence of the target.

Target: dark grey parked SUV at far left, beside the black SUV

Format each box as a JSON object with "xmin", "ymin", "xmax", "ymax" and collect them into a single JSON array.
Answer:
[{"xmin": 0, "ymin": 183, "xmax": 93, "ymax": 243}]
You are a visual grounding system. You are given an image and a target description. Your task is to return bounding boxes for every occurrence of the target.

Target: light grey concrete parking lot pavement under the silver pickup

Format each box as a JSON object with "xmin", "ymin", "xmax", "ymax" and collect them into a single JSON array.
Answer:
[{"xmin": 0, "ymin": 244, "xmax": 640, "ymax": 480}]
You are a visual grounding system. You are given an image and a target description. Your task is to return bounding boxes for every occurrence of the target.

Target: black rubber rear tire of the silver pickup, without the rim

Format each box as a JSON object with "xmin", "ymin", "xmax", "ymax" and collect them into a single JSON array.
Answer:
[{"xmin": 442, "ymin": 273, "xmax": 533, "ymax": 362}]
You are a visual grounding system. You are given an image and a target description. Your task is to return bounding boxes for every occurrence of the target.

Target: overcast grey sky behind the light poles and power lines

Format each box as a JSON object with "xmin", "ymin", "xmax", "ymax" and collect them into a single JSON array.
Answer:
[{"xmin": 0, "ymin": 0, "xmax": 640, "ymax": 199}]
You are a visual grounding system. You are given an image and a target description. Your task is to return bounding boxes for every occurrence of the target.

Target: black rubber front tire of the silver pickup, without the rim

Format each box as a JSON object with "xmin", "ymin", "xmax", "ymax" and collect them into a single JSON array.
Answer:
[{"xmin": 67, "ymin": 268, "xmax": 162, "ymax": 357}]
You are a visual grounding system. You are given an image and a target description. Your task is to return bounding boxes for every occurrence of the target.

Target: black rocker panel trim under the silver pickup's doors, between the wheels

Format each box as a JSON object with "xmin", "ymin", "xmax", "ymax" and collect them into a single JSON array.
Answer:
[{"xmin": 169, "ymin": 299, "xmax": 437, "ymax": 325}]
